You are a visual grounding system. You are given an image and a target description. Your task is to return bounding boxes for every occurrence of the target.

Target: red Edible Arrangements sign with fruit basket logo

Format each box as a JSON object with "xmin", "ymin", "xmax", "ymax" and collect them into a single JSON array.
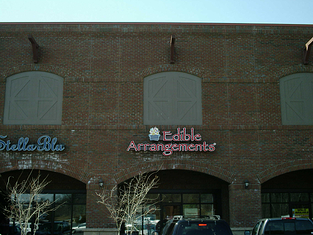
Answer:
[{"xmin": 127, "ymin": 127, "xmax": 216, "ymax": 156}]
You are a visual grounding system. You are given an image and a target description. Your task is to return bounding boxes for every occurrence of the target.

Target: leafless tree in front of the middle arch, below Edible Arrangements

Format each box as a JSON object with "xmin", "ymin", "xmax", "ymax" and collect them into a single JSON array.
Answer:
[{"xmin": 96, "ymin": 173, "xmax": 159, "ymax": 234}]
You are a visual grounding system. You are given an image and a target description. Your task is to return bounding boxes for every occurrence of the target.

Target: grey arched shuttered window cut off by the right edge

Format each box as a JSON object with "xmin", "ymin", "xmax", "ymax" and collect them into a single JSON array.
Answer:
[{"xmin": 280, "ymin": 73, "xmax": 313, "ymax": 125}]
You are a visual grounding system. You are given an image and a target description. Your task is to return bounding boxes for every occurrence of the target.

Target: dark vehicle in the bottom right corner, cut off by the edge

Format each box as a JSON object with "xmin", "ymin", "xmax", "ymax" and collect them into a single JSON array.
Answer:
[{"xmin": 249, "ymin": 217, "xmax": 313, "ymax": 235}]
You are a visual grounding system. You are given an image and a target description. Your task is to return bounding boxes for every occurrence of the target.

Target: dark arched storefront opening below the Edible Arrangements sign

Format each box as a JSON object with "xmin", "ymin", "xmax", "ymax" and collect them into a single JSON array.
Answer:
[{"xmin": 120, "ymin": 170, "xmax": 229, "ymax": 234}]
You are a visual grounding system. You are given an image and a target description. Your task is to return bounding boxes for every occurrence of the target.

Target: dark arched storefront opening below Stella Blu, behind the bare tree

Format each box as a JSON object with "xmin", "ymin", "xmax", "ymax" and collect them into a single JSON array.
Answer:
[{"xmin": 0, "ymin": 170, "xmax": 86, "ymax": 235}]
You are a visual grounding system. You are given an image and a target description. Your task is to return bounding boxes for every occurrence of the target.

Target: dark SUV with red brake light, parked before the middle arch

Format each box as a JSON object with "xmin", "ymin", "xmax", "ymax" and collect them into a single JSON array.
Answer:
[{"xmin": 162, "ymin": 216, "xmax": 232, "ymax": 235}]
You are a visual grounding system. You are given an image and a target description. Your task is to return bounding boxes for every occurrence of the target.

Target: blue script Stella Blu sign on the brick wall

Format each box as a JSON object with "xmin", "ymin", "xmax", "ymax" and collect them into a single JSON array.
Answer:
[{"xmin": 0, "ymin": 135, "xmax": 65, "ymax": 152}]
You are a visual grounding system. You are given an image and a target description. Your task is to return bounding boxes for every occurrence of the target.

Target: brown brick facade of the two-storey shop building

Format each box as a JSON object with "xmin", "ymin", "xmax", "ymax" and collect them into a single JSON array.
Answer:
[{"xmin": 0, "ymin": 23, "xmax": 313, "ymax": 228}]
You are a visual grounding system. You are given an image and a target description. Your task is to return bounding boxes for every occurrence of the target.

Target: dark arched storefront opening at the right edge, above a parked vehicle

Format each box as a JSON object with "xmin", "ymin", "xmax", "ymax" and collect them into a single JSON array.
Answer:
[{"xmin": 262, "ymin": 169, "xmax": 313, "ymax": 218}]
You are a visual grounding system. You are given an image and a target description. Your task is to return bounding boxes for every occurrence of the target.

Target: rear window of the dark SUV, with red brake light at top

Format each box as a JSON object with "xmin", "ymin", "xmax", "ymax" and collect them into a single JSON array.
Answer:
[{"xmin": 175, "ymin": 221, "xmax": 231, "ymax": 235}]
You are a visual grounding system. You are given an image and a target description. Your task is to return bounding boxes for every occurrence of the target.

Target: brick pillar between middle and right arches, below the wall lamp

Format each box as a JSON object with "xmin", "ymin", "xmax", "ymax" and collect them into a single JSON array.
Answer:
[{"xmin": 229, "ymin": 183, "xmax": 262, "ymax": 228}]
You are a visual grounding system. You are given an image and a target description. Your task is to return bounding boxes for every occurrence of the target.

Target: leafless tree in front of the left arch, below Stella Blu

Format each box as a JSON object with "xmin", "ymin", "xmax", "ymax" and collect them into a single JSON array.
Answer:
[{"xmin": 4, "ymin": 171, "xmax": 55, "ymax": 235}]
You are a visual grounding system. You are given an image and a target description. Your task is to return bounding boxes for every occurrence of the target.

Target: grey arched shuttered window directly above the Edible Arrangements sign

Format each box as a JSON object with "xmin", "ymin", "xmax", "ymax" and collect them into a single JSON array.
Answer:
[{"xmin": 144, "ymin": 72, "xmax": 202, "ymax": 125}]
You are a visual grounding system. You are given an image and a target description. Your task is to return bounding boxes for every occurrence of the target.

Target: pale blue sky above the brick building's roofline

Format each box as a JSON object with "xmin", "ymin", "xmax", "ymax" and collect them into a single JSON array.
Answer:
[{"xmin": 0, "ymin": 0, "xmax": 313, "ymax": 24}]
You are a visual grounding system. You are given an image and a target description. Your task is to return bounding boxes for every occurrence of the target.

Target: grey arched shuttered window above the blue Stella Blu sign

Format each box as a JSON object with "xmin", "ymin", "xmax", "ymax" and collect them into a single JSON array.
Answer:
[{"xmin": 3, "ymin": 71, "xmax": 63, "ymax": 125}]
